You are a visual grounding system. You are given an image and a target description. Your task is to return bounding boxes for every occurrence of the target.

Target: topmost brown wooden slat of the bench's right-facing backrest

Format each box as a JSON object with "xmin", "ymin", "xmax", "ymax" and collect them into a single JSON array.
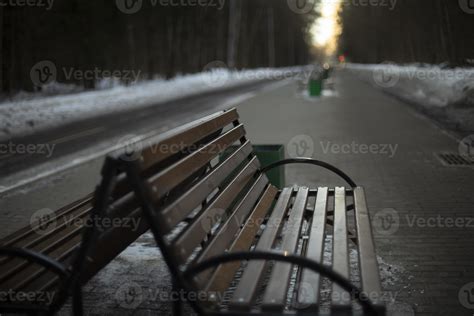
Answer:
[{"xmin": 142, "ymin": 109, "xmax": 239, "ymax": 169}]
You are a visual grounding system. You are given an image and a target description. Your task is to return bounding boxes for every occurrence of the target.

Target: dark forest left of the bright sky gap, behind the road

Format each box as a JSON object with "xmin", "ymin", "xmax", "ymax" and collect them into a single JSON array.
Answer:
[{"xmin": 0, "ymin": 0, "xmax": 314, "ymax": 93}]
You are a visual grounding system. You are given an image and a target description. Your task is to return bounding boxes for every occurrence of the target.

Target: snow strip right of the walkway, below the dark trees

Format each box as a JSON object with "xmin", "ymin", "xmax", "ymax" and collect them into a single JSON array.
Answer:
[{"xmin": 345, "ymin": 63, "xmax": 474, "ymax": 134}]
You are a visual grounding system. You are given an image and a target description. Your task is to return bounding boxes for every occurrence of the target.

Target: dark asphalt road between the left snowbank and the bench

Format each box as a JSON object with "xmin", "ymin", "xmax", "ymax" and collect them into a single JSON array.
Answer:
[{"xmin": 0, "ymin": 81, "xmax": 286, "ymax": 195}]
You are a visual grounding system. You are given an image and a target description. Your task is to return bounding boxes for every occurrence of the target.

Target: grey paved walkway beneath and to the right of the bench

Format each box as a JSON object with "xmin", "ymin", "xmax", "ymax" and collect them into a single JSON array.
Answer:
[{"xmin": 3, "ymin": 70, "xmax": 474, "ymax": 315}]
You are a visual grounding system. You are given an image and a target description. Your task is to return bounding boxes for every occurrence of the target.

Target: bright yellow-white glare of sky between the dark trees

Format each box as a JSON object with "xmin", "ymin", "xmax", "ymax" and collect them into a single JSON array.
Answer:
[{"xmin": 311, "ymin": 0, "xmax": 340, "ymax": 55}]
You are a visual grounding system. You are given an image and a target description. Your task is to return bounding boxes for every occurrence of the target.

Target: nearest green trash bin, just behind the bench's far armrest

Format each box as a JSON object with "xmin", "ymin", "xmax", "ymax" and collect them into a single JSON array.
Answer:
[{"xmin": 253, "ymin": 145, "xmax": 285, "ymax": 189}]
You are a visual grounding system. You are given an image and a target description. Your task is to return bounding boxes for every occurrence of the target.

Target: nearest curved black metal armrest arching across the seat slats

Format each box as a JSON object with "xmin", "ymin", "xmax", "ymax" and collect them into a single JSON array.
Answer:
[{"xmin": 183, "ymin": 251, "xmax": 378, "ymax": 315}]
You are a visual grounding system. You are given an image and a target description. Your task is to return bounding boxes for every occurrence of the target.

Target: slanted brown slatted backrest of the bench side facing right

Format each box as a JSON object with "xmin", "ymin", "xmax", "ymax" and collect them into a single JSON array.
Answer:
[{"xmin": 100, "ymin": 109, "xmax": 270, "ymax": 286}]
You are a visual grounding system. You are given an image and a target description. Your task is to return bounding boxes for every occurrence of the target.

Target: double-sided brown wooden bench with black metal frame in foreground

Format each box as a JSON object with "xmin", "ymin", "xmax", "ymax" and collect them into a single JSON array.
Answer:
[{"xmin": 0, "ymin": 109, "xmax": 385, "ymax": 315}]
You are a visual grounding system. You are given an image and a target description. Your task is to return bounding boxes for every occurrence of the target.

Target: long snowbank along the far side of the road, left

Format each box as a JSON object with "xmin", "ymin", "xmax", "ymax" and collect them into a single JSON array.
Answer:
[{"xmin": 0, "ymin": 67, "xmax": 304, "ymax": 140}]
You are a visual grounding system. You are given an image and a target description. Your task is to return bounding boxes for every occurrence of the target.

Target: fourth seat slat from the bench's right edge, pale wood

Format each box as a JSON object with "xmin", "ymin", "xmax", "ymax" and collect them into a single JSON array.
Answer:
[{"xmin": 262, "ymin": 187, "xmax": 308, "ymax": 310}]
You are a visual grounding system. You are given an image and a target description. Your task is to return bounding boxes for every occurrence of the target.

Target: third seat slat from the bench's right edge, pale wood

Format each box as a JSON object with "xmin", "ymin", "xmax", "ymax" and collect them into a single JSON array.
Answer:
[{"xmin": 296, "ymin": 188, "xmax": 328, "ymax": 310}]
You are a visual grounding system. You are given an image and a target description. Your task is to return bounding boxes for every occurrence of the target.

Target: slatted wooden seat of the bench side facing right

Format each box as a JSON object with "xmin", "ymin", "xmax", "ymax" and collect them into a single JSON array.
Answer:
[{"xmin": 178, "ymin": 185, "xmax": 383, "ymax": 315}]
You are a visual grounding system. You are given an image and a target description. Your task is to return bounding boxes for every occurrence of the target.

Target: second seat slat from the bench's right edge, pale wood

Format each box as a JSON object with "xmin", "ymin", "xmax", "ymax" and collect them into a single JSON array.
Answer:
[{"xmin": 332, "ymin": 187, "xmax": 352, "ymax": 314}]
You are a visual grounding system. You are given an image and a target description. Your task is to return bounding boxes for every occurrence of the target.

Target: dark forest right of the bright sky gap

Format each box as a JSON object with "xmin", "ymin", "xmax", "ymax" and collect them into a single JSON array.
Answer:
[{"xmin": 340, "ymin": 0, "xmax": 474, "ymax": 65}]
